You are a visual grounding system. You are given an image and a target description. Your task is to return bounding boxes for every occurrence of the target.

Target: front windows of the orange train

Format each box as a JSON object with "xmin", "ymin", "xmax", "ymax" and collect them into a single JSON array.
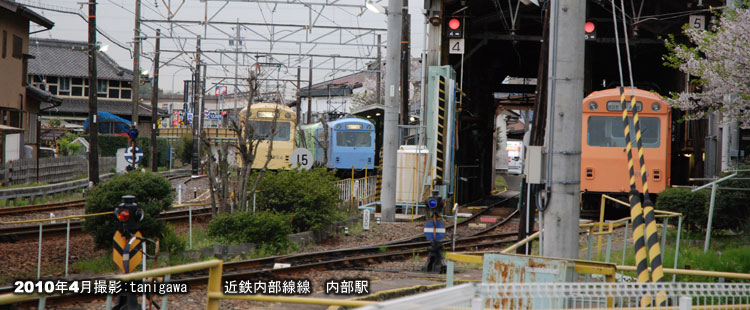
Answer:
[{"xmin": 586, "ymin": 116, "xmax": 661, "ymax": 148}]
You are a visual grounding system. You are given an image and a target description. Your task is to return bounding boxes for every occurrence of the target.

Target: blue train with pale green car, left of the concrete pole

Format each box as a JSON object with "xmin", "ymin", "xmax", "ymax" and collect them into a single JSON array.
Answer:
[{"xmin": 297, "ymin": 117, "xmax": 375, "ymax": 170}]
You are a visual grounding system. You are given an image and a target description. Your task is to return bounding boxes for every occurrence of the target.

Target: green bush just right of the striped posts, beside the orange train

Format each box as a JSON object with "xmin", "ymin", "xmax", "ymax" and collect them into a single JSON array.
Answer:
[{"xmin": 656, "ymin": 187, "xmax": 711, "ymax": 231}]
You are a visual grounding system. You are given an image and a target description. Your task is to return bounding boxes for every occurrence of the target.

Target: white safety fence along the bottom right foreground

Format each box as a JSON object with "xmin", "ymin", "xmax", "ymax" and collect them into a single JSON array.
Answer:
[{"xmin": 358, "ymin": 283, "xmax": 750, "ymax": 310}]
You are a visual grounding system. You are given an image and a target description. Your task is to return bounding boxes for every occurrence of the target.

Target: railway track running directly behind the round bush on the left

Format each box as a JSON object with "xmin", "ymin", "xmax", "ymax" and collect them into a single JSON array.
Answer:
[{"xmin": 0, "ymin": 207, "xmax": 211, "ymax": 242}]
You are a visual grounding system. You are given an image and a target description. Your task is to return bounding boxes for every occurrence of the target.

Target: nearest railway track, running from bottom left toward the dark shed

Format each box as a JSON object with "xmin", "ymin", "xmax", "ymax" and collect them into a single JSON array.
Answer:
[{"xmin": 7, "ymin": 197, "xmax": 517, "ymax": 304}]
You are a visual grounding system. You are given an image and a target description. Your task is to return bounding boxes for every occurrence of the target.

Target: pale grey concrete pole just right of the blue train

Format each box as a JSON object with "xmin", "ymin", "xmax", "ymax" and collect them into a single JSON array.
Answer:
[{"xmin": 380, "ymin": 0, "xmax": 402, "ymax": 222}]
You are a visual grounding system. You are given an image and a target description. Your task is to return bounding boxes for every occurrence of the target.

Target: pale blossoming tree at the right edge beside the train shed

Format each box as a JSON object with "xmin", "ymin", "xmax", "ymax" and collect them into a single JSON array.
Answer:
[{"xmin": 664, "ymin": 9, "xmax": 750, "ymax": 127}]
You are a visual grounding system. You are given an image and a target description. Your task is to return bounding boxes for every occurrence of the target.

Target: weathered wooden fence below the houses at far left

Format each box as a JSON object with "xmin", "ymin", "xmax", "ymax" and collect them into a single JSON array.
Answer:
[{"xmin": 0, "ymin": 156, "xmax": 116, "ymax": 186}]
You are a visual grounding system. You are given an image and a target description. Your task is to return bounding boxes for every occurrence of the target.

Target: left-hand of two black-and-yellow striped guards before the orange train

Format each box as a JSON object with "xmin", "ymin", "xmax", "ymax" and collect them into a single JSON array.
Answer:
[{"xmin": 620, "ymin": 87, "xmax": 651, "ymax": 296}]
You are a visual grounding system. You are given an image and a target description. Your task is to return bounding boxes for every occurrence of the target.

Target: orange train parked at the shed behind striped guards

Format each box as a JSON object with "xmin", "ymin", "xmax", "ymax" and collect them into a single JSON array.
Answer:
[{"xmin": 581, "ymin": 88, "xmax": 672, "ymax": 206}]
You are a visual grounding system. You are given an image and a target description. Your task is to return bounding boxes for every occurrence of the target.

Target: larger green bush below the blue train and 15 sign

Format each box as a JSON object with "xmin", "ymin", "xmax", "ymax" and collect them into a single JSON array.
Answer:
[{"xmin": 250, "ymin": 168, "xmax": 343, "ymax": 232}]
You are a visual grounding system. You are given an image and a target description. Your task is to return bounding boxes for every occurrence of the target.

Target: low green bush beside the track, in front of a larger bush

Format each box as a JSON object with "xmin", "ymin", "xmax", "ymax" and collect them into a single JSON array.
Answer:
[{"xmin": 208, "ymin": 211, "xmax": 292, "ymax": 251}]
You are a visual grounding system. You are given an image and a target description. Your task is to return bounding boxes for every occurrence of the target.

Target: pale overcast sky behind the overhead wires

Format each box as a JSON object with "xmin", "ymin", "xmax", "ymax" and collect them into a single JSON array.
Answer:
[{"xmin": 17, "ymin": 0, "xmax": 424, "ymax": 97}]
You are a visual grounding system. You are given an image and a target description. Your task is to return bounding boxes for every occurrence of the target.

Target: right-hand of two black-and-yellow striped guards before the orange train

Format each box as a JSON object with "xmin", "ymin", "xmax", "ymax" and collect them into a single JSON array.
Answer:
[{"xmin": 623, "ymin": 94, "xmax": 667, "ymax": 307}]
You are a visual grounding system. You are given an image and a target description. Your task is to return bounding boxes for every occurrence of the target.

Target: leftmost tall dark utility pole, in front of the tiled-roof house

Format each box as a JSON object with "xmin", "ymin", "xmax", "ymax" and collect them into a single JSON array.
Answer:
[{"xmin": 87, "ymin": 1, "xmax": 99, "ymax": 185}]
